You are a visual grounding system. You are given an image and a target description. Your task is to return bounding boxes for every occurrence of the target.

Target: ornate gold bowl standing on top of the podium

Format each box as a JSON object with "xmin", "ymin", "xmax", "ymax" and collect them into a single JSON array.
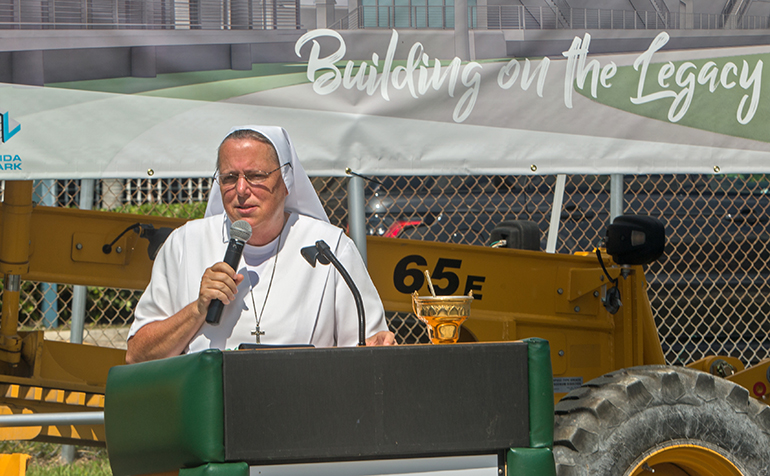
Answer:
[{"xmin": 412, "ymin": 271, "xmax": 473, "ymax": 344}]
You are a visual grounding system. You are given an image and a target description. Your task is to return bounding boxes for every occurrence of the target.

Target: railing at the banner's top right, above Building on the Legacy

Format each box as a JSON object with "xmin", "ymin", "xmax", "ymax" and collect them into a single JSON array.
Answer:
[{"xmin": 331, "ymin": 4, "xmax": 770, "ymax": 30}]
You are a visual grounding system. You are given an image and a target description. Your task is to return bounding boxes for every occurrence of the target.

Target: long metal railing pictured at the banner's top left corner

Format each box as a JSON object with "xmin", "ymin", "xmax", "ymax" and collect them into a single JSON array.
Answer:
[{"xmin": 0, "ymin": 0, "xmax": 300, "ymax": 30}]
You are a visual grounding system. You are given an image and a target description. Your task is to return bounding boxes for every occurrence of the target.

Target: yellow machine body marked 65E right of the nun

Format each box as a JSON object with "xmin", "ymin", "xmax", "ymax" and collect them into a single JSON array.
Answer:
[{"xmin": 367, "ymin": 237, "xmax": 665, "ymax": 400}]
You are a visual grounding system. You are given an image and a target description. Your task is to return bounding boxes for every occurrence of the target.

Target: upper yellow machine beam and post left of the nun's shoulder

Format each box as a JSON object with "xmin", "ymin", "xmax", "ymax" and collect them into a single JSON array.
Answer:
[{"xmin": 0, "ymin": 181, "xmax": 186, "ymax": 366}]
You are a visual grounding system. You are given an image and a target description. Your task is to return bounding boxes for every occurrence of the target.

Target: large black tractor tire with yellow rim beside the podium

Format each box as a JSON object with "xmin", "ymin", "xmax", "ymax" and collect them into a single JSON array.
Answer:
[{"xmin": 554, "ymin": 366, "xmax": 770, "ymax": 476}]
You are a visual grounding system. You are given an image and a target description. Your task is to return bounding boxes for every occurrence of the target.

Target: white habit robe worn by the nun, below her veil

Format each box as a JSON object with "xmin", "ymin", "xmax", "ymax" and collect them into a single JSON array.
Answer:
[{"xmin": 129, "ymin": 213, "xmax": 387, "ymax": 352}]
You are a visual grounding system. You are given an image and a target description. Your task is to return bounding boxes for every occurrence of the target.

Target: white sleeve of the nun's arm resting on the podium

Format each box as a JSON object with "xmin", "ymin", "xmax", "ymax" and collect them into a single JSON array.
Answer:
[{"xmin": 333, "ymin": 234, "xmax": 388, "ymax": 347}]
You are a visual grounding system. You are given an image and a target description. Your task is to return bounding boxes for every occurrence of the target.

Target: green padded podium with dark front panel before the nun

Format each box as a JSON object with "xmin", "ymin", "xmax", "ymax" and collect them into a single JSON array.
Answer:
[{"xmin": 105, "ymin": 339, "xmax": 554, "ymax": 476}]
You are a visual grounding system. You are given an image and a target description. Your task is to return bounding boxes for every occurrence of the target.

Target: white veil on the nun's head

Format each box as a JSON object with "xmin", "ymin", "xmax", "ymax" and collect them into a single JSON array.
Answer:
[{"xmin": 205, "ymin": 126, "xmax": 329, "ymax": 223}]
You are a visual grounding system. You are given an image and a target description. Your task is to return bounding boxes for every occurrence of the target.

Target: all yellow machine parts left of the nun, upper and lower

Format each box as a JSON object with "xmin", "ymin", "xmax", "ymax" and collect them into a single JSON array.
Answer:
[{"xmin": 0, "ymin": 181, "xmax": 173, "ymax": 445}]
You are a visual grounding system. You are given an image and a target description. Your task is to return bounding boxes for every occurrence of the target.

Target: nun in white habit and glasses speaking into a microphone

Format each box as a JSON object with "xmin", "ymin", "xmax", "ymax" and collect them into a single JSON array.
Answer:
[{"xmin": 126, "ymin": 126, "xmax": 395, "ymax": 363}]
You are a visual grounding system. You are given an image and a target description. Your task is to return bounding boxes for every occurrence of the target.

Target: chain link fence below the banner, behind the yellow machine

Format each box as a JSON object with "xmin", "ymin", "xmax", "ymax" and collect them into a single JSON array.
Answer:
[{"xmin": 7, "ymin": 175, "xmax": 770, "ymax": 364}]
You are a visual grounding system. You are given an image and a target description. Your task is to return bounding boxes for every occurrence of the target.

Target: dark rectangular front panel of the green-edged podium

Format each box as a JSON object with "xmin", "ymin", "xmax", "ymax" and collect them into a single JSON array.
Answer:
[{"xmin": 223, "ymin": 342, "xmax": 530, "ymax": 464}]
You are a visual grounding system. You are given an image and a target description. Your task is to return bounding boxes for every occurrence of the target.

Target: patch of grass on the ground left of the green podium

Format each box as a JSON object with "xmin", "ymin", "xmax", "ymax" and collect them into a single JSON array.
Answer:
[{"xmin": 0, "ymin": 441, "xmax": 112, "ymax": 476}]
